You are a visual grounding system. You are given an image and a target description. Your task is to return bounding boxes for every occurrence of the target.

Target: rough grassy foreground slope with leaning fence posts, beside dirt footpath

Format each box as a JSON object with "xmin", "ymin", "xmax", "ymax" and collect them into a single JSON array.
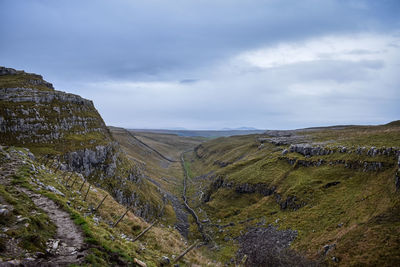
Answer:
[{"xmin": 0, "ymin": 147, "xmax": 216, "ymax": 266}]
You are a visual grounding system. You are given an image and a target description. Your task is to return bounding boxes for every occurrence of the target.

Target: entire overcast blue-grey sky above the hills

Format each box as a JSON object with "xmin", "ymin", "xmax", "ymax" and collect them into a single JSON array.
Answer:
[{"xmin": 0, "ymin": 0, "xmax": 400, "ymax": 129}]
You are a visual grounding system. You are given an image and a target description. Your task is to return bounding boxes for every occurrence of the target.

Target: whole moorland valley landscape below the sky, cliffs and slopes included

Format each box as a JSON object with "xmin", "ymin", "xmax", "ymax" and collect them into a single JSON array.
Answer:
[{"xmin": 0, "ymin": 68, "xmax": 400, "ymax": 266}]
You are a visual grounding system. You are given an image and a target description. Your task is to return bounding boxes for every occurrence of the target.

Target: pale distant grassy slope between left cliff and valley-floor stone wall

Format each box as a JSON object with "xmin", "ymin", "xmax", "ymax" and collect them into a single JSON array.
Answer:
[{"xmin": 110, "ymin": 127, "xmax": 208, "ymax": 243}]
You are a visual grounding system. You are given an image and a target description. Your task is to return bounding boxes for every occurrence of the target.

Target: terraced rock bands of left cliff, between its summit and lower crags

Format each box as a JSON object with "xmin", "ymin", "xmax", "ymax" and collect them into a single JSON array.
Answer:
[{"xmin": 0, "ymin": 88, "xmax": 111, "ymax": 144}]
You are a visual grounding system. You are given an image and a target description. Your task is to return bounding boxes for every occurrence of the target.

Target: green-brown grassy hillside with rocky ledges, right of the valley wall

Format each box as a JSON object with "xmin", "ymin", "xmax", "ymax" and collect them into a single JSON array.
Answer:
[{"xmin": 186, "ymin": 123, "xmax": 400, "ymax": 266}]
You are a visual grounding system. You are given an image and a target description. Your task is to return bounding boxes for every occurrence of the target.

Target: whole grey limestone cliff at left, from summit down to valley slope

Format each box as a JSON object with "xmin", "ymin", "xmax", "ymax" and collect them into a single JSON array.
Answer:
[{"xmin": 0, "ymin": 67, "xmax": 161, "ymax": 218}]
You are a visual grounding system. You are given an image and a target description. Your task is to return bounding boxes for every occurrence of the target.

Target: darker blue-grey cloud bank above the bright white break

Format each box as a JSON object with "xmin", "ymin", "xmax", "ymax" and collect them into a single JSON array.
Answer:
[{"xmin": 0, "ymin": 0, "xmax": 398, "ymax": 80}]
